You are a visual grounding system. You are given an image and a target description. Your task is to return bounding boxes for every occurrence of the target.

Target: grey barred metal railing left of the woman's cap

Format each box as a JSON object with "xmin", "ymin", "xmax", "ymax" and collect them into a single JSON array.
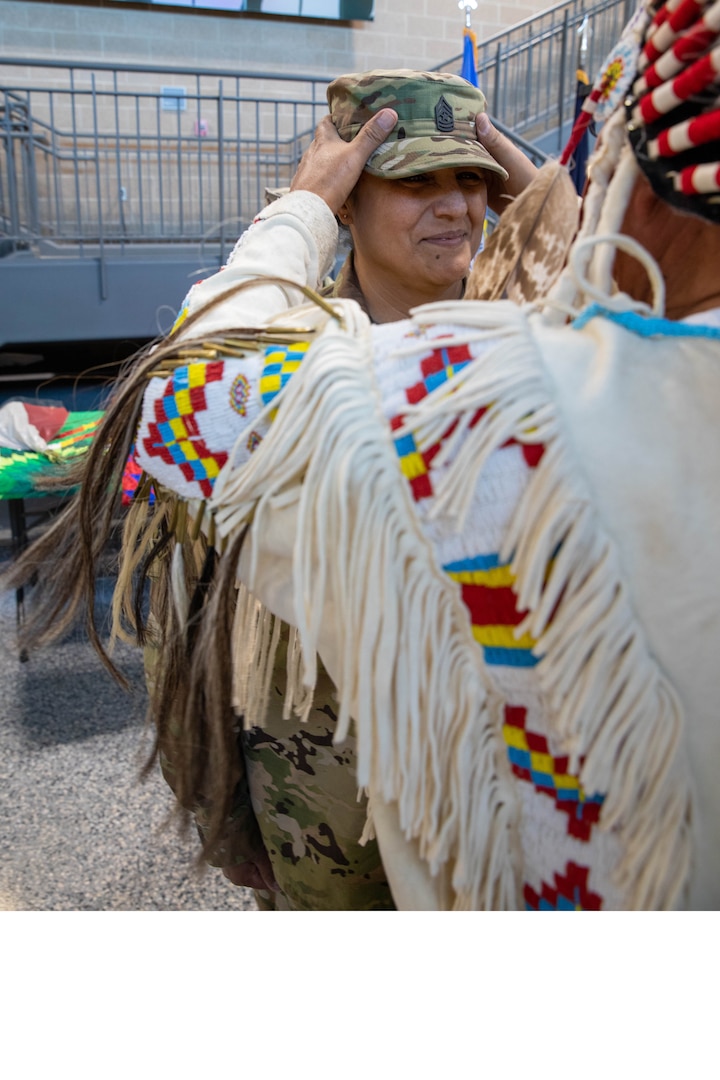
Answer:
[{"xmin": 0, "ymin": 66, "xmax": 327, "ymax": 263}]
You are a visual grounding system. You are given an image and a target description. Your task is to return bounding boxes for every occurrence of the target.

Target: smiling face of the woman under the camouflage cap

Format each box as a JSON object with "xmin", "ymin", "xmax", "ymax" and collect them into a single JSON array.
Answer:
[{"xmin": 347, "ymin": 166, "xmax": 487, "ymax": 301}]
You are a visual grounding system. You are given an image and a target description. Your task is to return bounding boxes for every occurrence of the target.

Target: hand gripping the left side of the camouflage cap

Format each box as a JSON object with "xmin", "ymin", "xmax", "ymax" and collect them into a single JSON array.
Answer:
[{"xmin": 290, "ymin": 109, "xmax": 397, "ymax": 214}]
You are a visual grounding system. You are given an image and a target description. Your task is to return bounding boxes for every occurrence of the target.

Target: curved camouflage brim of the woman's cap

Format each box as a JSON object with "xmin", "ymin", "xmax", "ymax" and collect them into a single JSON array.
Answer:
[{"xmin": 365, "ymin": 135, "xmax": 507, "ymax": 180}]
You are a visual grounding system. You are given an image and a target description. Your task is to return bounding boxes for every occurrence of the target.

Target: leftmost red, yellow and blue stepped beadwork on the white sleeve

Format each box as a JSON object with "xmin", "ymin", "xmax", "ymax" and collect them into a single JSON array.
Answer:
[{"xmin": 142, "ymin": 361, "xmax": 228, "ymax": 498}]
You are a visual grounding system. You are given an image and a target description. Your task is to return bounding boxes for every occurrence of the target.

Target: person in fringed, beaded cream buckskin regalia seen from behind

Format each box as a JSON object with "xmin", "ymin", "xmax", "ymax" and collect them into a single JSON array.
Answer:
[{"xmin": 5, "ymin": 14, "xmax": 720, "ymax": 909}]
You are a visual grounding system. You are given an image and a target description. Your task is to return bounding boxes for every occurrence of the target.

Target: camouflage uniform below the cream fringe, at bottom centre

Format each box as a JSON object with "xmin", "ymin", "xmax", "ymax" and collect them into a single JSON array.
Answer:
[{"xmin": 243, "ymin": 630, "xmax": 394, "ymax": 910}]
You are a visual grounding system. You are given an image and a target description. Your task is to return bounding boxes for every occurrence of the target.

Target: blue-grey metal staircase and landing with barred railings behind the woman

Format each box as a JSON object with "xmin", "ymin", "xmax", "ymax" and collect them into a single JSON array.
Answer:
[{"xmin": 0, "ymin": 0, "xmax": 634, "ymax": 356}]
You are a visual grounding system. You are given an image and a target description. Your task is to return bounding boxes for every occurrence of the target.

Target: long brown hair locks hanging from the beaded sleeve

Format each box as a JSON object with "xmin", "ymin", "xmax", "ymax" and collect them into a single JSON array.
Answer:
[{"xmin": 0, "ymin": 288, "xmax": 264, "ymax": 862}]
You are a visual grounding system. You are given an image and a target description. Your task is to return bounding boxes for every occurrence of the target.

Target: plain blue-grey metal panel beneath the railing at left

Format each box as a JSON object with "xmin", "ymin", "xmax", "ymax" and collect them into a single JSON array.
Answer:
[{"xmin": 0, "ymin": 248, "xmax": 220, "ymax": 347}]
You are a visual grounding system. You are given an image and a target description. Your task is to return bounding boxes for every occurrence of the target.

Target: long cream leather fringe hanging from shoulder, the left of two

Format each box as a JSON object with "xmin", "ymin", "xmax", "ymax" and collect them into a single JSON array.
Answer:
[{"xmin": 212, "ymin": 298, "xmax": 519, "ymax": 908}]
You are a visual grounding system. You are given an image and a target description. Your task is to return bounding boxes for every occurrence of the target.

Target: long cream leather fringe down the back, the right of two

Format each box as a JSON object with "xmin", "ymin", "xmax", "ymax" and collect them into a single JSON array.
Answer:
[{"xmin": 396, "ymin": 305, "xmax": 692, "ymax": 909}]
